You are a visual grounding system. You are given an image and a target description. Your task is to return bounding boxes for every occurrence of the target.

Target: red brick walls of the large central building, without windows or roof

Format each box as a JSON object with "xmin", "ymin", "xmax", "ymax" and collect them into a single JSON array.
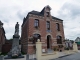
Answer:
[{"xmin": 21, "ymin": 5, "xmax": 64, "ymax": 54}]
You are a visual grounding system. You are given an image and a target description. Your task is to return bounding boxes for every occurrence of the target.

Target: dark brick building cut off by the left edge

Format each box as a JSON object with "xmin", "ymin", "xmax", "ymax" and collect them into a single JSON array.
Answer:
[{"xmin": 0, "ymin": 21, "xmax": 6, "ymax": 52}]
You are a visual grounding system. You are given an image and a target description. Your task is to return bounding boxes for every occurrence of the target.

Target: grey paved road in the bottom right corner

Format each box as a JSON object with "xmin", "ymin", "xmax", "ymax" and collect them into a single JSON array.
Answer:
[{"xmin": 51, "ymin": 53, "xmax": 80, "ymax": 60}]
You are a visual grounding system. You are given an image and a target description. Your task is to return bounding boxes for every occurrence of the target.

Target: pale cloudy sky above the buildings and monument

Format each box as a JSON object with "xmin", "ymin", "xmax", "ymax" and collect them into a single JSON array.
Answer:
[{"xmin": 0, "ymin": 0, "xmax": 80, "ymax": 40}]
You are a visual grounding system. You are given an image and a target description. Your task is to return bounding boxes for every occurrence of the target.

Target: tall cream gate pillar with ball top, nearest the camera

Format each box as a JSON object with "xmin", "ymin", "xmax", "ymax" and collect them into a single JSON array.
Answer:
[{"xmin": 36, "ymin": 39, "xmax": 42, "ymax": 60}]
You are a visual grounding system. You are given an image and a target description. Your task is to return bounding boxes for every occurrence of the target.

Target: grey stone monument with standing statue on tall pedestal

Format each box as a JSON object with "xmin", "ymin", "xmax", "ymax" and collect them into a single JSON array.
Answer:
[{"xmin": 4, "ymin": 22, "xmax": 24, "ymax": 58}]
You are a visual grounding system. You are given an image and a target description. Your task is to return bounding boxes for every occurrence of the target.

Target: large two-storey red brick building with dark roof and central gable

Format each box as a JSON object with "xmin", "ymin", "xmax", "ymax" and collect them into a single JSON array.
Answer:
[{"xmin": 21, "ymin": 6, "xmax": 65, "ymax": 54}]
